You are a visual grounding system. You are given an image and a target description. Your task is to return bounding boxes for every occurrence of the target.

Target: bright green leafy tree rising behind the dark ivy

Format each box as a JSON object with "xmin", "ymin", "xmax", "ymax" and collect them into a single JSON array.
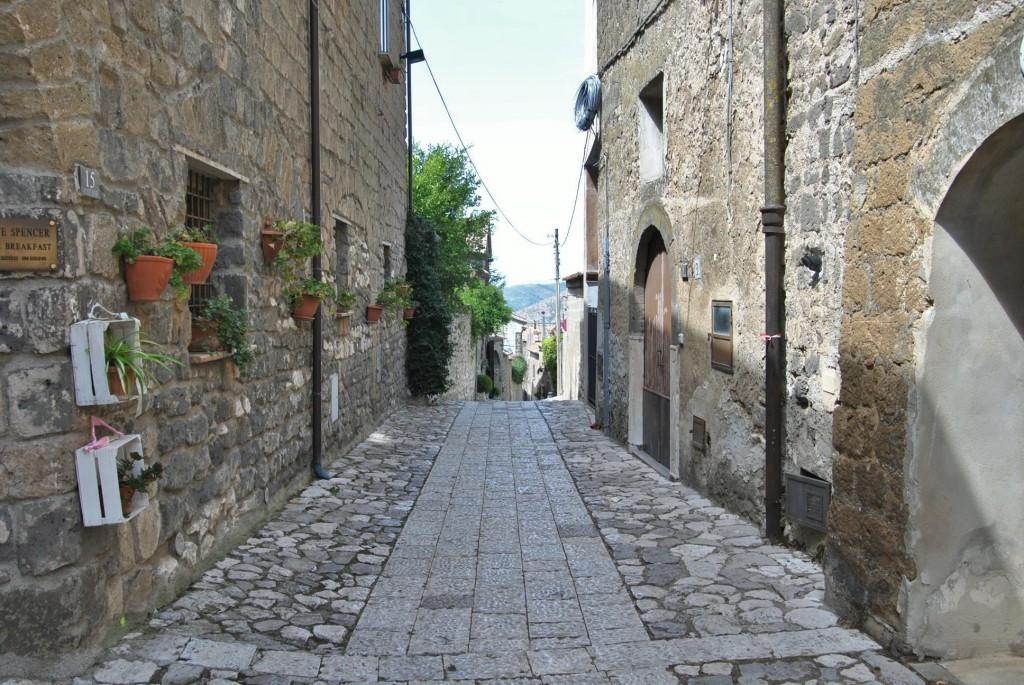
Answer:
[{"xmin": 413, "ymin": 144, "xmax": 495, "ymax": 307}]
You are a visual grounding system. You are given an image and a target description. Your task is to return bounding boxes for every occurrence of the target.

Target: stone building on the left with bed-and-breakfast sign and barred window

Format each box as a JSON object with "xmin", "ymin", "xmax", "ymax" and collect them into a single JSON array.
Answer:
[{"xmin": 0, "ymin": 0, "xmax": 407, "ymax": 675}]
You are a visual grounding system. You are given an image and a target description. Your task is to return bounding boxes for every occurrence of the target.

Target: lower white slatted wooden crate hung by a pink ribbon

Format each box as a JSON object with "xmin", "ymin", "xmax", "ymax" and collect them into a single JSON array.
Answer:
[{"xmin": 75, "ymin": 433, "xmax": 150, "ymax": 525}]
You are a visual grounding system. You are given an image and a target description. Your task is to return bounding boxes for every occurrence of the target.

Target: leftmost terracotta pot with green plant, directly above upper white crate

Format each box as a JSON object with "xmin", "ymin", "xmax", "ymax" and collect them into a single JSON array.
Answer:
[{"xmin": 111, "ymin": 226, "xmax": 203, "ymax": 302}]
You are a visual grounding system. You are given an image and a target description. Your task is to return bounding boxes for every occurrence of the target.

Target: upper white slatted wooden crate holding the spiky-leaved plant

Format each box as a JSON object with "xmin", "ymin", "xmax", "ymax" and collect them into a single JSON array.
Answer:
[{"xmin": 71, "ymin": 313, "xmax": 139, "ymax": 406}]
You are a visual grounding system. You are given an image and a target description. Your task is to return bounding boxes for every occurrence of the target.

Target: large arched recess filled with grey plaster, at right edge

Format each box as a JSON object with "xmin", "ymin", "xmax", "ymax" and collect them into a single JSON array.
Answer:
[{"xmin": 906, "ymin": 115, "xmax": 1024, "ymax": 656}]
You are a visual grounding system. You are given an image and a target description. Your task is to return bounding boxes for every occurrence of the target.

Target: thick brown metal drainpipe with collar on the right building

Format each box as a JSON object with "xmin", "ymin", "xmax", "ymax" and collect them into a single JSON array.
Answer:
[{"xmin": 761, "ymin": 0, "xmax": 785, "ymax": 541}]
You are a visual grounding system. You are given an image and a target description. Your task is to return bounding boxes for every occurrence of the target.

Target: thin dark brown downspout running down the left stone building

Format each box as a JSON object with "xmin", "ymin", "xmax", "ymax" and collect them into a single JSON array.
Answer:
[{"xmin": 309, "ymin": 0, "xmax": 333, "ymax": 478}]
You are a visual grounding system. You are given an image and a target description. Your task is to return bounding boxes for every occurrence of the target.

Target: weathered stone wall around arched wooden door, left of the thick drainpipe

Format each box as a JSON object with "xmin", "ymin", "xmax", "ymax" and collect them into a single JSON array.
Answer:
[{"xmin": 597, "ymin": 1, "xmax": 764, "ymax": 520}]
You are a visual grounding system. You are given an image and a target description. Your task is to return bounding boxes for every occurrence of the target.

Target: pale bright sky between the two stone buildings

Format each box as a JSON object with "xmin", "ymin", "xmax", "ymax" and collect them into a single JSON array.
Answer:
[{"xmin": 411, "ymin": 0, "xmax": 588, "ymax": 286}]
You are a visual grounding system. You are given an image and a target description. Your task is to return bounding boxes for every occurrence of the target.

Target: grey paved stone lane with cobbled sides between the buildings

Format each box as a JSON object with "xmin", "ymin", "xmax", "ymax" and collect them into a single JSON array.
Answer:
[{"xmin": 6, "ymin": 401, "xmax": 937, "ymax": 685}]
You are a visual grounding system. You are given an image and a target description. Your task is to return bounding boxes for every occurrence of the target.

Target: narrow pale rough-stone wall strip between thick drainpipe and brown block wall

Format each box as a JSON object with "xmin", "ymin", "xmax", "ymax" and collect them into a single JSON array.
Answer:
[{"xmin": 783, "ymin": 0, "xmax": 858, "ymax": 549}]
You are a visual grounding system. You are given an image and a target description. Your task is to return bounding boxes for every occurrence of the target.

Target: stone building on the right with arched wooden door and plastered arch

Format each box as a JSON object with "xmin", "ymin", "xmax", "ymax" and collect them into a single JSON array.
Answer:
[{"xmin": 587, "ymin": 0, "xmax": 1024, "ymax": 656}]
